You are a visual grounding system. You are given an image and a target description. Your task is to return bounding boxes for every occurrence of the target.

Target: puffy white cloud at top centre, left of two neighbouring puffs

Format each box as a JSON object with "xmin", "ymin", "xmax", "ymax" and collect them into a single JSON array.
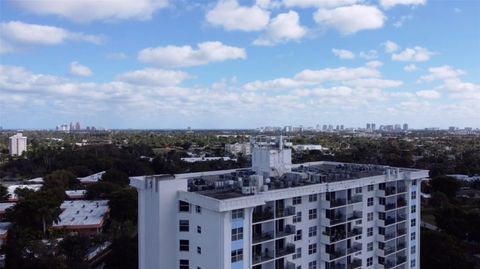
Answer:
[{"xmin": 206, "ymin": 0, "xmax": 270, "ymax": 32}]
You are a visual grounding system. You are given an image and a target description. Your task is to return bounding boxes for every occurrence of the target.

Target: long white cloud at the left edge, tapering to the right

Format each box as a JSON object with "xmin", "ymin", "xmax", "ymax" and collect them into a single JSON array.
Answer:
[{"xmin": 0, "ymin": 21, "xmax": 104, "ymax": 52}]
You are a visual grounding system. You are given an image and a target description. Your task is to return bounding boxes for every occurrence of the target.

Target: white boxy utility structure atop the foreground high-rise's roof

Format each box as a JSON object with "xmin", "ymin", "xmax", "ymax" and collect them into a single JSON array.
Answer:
[{"xmin": 252, "ymin": 136, "xmax": 292, "ymax": 178}]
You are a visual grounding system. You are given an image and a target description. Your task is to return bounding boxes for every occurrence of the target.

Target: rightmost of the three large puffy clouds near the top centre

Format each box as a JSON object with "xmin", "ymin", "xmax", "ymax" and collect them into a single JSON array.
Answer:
[{"xmin": 314, "ymin": 5, "xmax": 387, "ymax": 35}]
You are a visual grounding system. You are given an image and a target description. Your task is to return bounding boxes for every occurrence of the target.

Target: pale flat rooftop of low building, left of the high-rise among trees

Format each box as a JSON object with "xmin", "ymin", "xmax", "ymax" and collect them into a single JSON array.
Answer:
[{"xmin": 53, "ymin": 200, "xmax": 109, "ymax": 229}]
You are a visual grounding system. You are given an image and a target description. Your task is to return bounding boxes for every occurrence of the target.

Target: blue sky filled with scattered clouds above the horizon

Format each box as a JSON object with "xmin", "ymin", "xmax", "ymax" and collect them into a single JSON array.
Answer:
[{"xmin": 0, "ymin": 0, "xmax": 480, "ymax": 128}]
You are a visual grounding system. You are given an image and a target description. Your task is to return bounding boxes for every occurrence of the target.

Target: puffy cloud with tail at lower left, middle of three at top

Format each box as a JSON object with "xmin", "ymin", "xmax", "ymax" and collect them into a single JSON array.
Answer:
[{"xmin": 253, "ymin": 11, "xmax": 307, "ymax": 46}]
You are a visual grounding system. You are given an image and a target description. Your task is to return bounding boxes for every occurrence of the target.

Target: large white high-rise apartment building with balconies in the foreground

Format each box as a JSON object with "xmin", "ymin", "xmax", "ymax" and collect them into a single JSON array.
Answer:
[{"xmin": 130, "ymin": 136, "xmax": 428, "ymax": 269}]
